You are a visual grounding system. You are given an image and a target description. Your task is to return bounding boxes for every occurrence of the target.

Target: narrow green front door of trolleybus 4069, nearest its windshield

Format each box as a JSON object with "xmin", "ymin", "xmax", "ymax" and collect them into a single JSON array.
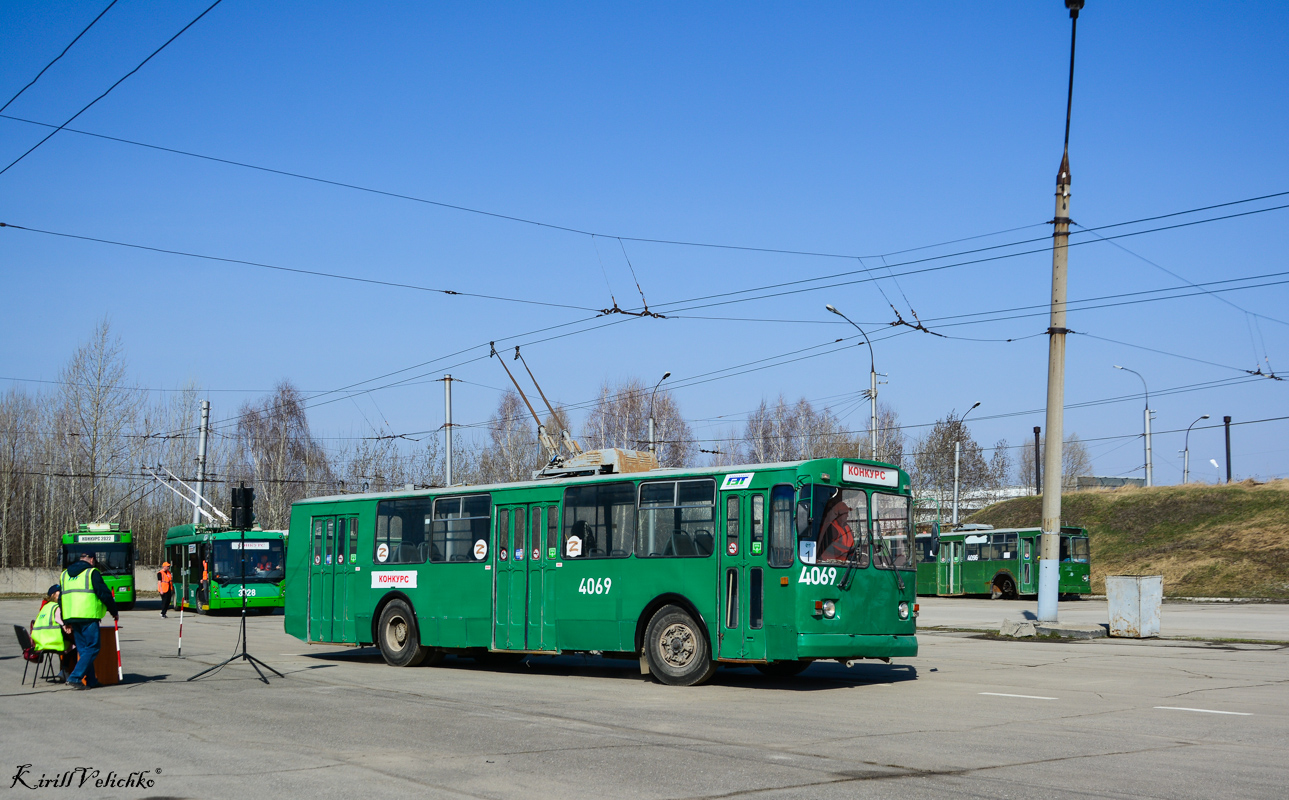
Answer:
[{"xmin": 717, "ymin": 492, "xmax": 766, "ymax": 661}]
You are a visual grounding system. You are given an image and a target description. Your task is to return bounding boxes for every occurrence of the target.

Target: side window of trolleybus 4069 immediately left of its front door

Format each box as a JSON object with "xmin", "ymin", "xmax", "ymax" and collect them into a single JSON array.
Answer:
[{"xmin": 635, "ymin": 479, "xmax": 717, "ymax": 558}]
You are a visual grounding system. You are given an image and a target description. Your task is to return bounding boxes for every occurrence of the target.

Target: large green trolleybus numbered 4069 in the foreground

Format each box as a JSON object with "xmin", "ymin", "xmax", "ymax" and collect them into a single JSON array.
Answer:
[{"xmin": 286, "ymin": 459, "xmax": 918, "ymax": 685}]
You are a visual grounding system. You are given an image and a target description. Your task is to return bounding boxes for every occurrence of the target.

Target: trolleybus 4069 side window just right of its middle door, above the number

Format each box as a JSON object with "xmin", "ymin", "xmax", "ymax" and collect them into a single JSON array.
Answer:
[{"xmin": 563, "ymin": 481, "xmax": 635, "ymax": 558}]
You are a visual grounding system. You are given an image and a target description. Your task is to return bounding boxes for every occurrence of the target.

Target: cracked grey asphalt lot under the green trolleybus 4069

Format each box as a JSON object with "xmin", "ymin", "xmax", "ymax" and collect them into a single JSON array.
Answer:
[{"xmin": 0, "ymin": 600, "xmax": 1289, "ymax": 800}]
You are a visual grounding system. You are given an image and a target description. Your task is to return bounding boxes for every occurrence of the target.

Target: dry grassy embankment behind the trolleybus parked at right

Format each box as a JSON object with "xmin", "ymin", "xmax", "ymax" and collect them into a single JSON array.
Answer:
[{"xmin": 965, "ymin": 481, "xmax": 1289, "ymax": 598}]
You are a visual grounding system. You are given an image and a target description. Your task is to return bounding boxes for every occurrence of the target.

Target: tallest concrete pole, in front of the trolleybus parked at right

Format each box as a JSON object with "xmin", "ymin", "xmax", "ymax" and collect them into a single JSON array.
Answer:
[{"xmin": 1034, "ymin": 0, "xmax": 1083, "ymax": 622}]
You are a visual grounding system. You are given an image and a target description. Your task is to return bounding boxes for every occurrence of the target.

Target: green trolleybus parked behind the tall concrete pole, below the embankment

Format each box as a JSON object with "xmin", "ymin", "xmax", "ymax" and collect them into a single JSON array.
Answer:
[{"xmin": 916, "ymin": 526, "xmax": 1092, "ymax": 599}]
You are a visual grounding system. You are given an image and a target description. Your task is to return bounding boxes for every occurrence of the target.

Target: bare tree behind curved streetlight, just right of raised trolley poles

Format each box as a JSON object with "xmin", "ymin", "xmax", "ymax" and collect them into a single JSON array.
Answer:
[{"xmin": 581, "ymin": 377, "xmax": 696, "ymax": 466}]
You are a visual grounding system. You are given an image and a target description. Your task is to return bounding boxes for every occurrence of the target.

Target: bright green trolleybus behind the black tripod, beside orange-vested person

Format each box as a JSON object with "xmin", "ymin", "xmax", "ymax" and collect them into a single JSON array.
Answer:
[{"xmin": 165, "ymin": 524, "xmax": 286, "ymax": 613}]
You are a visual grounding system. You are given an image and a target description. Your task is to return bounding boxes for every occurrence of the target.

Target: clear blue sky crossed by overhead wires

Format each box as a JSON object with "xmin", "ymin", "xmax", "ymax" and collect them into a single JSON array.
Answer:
[{"xmin": 0, "ymin": 0, "xmax": 1289, "ymax": 483}]
